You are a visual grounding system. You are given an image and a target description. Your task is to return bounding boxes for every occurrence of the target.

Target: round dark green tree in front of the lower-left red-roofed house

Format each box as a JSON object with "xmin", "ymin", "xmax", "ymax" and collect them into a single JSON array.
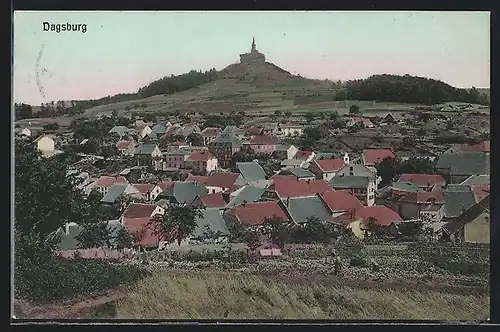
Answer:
[{"xmin": 151, "ymin": 205, "xmax": 203, "ymax": 245}]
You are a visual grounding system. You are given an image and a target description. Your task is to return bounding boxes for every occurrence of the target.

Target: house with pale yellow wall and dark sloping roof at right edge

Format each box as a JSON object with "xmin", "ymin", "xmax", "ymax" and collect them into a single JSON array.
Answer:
[{"xmin": 442, "ymin": 195, "xmax": 491, "ymax": 243}]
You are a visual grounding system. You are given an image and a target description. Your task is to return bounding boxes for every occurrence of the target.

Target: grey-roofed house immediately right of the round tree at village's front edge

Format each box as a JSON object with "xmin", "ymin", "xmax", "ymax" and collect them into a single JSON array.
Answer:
[{"xmin": 191, "ymin": 208, "xmax": 229, "ymax": 241}]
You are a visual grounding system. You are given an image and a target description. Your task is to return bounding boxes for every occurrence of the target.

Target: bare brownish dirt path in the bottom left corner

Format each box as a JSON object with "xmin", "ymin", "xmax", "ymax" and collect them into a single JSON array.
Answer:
[{"xmin": 14, "ymin": 290, "xmax": 125, "ymax": 319}]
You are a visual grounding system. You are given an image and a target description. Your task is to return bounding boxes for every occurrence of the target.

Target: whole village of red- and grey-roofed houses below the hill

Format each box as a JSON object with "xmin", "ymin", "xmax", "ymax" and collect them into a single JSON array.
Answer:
[{"xmin": 16, "ymin": 107, "xmax": 490, "ymax": 256}]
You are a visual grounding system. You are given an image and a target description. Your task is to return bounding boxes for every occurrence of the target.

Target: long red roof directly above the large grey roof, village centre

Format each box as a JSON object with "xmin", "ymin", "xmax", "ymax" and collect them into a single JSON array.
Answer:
[{"xmin": 268, "ymin": 178, "xmax": 333, "ymax": 198}]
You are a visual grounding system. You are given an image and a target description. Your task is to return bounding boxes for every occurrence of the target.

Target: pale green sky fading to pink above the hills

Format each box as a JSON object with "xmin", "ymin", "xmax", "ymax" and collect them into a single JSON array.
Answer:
[{"xmin": 14, "ymin": 11, "xmax": 490, "ymax": 105}]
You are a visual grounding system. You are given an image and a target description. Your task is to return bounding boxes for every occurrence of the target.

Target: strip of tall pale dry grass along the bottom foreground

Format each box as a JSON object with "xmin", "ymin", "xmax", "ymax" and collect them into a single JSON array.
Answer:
[{"xmin": 107, "ymin": 270, "xmax": 489, "ymax": 320}]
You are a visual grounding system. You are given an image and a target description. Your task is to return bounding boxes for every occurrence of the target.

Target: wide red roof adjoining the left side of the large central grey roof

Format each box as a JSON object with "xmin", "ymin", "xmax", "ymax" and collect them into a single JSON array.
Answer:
[{"xmin": 227, "ymin": 201, "xmax": 290, "ymax": 225}]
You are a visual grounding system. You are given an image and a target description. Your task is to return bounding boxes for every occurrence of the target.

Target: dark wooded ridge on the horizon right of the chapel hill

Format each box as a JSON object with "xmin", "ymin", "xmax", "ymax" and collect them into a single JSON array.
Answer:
[{"xmin": 335, "ymin": 74, "xmax": 490, "ymax": 105}]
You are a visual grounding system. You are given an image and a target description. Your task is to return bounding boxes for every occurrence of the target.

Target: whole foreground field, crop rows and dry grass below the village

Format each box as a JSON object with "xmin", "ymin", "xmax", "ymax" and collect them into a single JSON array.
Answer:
[{"xmin": 70, "ymin": 245, "xmax": 489, "ymax": 320}]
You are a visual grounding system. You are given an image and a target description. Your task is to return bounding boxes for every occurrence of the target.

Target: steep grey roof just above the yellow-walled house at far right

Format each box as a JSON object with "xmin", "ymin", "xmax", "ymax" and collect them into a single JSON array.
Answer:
[{"xmin": 443, "ymin": 185, "xmax": 476, "ymax": 221}]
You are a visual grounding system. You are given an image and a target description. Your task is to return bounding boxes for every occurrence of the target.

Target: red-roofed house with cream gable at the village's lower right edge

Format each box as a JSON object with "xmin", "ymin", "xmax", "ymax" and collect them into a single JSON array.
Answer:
[{"xmin": 337, "ymin": 205, "xmax": 403, "ymax": 239}]
